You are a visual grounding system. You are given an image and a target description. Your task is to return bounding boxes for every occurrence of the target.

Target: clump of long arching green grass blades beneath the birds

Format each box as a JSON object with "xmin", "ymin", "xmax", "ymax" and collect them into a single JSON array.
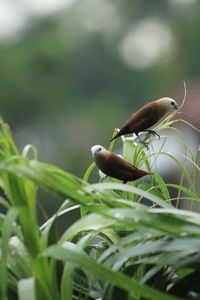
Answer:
[{"xmin": 0, "ymin": 112, "xmax": 200, "ymax": 300}]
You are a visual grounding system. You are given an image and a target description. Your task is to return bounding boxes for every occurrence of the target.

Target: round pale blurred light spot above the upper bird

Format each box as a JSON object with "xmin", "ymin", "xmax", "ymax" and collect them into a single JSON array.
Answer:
[{"xmin": 119, "ymin": 18, "xmax": 174, "ymax": 69}]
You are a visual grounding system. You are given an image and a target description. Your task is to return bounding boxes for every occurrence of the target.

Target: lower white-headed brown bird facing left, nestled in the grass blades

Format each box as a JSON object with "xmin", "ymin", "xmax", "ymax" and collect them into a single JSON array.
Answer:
[{"xmin": 91, "ymin": 145, "xmax": 154, "ymax": 183}]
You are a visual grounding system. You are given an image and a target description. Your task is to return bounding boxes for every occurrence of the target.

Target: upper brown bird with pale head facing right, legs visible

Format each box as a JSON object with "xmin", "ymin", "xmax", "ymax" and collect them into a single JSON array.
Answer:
[{"xmin": 110, "ymin": 97, "xmax": 178, "ymax": 146}]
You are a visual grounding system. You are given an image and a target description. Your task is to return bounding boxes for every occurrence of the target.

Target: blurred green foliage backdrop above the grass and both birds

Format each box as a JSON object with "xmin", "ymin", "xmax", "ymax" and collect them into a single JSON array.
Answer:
[{"xmin": 0, "ymin": 0, "xmax": 200, "ymax": 196}]
